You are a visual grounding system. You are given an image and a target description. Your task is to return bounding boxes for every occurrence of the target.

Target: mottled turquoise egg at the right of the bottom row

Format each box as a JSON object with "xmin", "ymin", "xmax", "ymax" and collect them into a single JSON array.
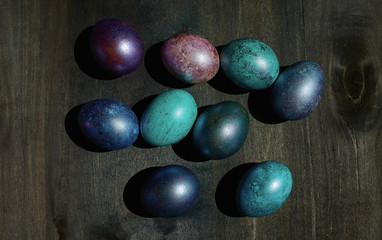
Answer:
[{"xmin": 236, "ymin": 161, "xmax": 293, "ymax": 217}]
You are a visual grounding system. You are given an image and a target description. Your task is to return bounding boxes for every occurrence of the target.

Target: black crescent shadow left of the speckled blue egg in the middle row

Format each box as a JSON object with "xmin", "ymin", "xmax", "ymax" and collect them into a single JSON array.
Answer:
[{"xmin": 65, "ymin": 104, "xmax": 109, "ymax": 152}]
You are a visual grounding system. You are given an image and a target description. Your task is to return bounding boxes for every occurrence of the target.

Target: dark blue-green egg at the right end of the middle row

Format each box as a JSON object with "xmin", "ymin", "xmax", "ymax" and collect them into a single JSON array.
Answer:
[{"xmin": 192, "ymin": 101, "xmax": 249, "ymax": 159}]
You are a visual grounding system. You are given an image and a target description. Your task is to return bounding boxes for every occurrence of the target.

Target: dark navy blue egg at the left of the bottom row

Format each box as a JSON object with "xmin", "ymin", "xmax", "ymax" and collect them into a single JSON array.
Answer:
[{"xmin": 141, "ymin": 165, "xmax": 200, "ymax": 217}]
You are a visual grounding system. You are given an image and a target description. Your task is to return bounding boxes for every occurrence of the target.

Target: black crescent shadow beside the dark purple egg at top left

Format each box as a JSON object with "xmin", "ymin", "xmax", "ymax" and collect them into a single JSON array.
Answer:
[{"xmin": 74, "ymin": 26, "xmax": 120, "ymax": 80}]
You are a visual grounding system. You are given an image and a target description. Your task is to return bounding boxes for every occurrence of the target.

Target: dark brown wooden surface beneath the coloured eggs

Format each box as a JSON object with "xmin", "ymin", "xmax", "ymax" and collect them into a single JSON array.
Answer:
[{"xmin": 0, "ymin": 0, "xmax": 382, "ymax": 240}]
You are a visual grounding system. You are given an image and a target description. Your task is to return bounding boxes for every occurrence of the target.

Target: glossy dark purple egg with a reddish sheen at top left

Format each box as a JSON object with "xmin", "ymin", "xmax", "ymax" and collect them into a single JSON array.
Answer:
[{"xmin": 90, "ymin": 18, "xmax": 144, "ymax": 76}]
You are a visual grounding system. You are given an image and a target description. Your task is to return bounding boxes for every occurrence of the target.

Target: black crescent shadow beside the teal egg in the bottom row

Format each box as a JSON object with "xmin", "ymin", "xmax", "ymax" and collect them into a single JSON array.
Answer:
[{"xmin": 215, "ymin": 163, "xmax": 256, "ymax": 217}]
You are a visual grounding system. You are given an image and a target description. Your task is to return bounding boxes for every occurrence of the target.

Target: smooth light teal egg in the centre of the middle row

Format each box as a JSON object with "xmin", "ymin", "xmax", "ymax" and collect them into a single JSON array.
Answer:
[{"xmin": 140, "ymin": 89, "xmax": 198, "ymax": 146}]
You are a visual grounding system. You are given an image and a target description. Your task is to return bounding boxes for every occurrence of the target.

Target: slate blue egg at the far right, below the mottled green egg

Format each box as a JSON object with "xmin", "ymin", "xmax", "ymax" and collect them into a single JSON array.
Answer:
[{"xmin": 272, "ymin": 61, "xmax": 325, "ymax": 120}]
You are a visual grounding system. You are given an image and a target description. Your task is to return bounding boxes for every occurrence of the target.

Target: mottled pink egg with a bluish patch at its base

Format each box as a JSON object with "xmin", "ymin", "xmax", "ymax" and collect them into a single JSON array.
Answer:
[{"xmin": 161, "ymin": 33, "xmax": 219, "ymax": 84}]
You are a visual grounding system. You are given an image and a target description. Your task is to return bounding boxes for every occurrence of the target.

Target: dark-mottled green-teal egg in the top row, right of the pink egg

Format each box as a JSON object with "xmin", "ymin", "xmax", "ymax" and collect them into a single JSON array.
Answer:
[{"xmin": 220, "ymin": 38, "xmax": 279, "ymax": 90}]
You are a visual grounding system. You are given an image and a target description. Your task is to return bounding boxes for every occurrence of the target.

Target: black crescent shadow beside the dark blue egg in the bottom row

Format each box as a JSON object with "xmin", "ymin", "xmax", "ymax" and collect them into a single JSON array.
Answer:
[{"xmin": 123, "ymin": 167, "xmax": 159, "ymax": 218}]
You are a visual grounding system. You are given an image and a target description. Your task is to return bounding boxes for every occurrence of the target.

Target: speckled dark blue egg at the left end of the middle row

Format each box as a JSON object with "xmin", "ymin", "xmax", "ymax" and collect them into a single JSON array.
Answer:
[{"xmin": 78, "ymin": 99, "xmax": 139, "ymax": 150}]
